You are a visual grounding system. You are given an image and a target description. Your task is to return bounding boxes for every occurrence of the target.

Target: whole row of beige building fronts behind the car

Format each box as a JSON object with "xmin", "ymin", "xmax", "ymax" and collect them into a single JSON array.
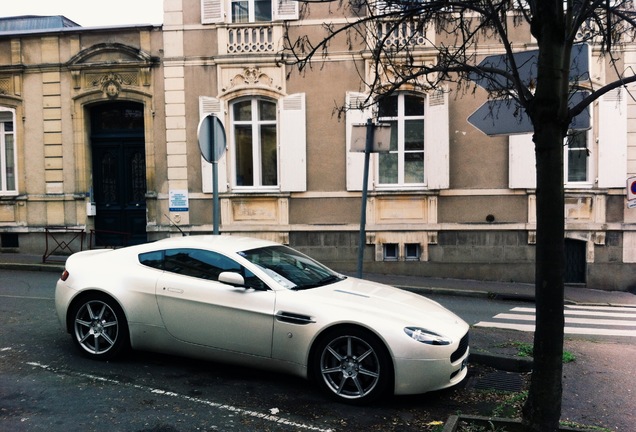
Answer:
[{"xmin": 0, "ymin": 0, "xmax": 636, "ymax": 290}]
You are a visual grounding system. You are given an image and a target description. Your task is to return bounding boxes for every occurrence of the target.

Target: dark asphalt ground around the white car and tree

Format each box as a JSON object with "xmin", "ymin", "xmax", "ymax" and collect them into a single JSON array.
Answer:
[{"xmin": 0, "ymin": 270, "xmax": 636, "ymax": 432}]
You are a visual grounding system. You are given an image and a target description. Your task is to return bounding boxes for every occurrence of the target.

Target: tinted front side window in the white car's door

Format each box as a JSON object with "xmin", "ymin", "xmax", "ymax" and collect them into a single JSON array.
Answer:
[{"xmin": 164, "ymin": 249, "xmax": 266, "ymax": 290}]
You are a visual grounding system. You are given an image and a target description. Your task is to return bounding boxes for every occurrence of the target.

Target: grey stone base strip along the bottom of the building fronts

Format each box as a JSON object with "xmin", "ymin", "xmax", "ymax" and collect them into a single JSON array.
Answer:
[{"xmin": 0, "ymin": 228, "xmax": 636, "ymax": 292}]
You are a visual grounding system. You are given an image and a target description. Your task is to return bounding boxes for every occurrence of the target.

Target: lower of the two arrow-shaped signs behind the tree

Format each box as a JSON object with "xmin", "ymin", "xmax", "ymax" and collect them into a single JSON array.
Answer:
[{"xmin": 468, "ymin": 91, "xmax": 590, "ymax": 136}]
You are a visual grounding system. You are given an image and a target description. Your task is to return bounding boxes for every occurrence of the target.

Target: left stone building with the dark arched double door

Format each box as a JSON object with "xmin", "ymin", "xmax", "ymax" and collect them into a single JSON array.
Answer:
[{"xmin": 0, "ymin": 16, "xmax": 165, "ymax": 258}]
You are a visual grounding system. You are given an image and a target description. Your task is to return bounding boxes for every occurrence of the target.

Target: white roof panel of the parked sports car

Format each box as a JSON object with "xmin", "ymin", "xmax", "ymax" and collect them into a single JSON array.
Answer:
[{"xmin": 148, "ymin": 234, "xmax": 280, "ymax": 252}]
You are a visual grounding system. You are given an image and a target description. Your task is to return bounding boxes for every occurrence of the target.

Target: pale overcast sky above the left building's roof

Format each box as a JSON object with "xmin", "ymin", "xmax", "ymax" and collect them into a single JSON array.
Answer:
[{"xmin": 0, "ymin": 0, "xmax": 163, "ymax": 27}]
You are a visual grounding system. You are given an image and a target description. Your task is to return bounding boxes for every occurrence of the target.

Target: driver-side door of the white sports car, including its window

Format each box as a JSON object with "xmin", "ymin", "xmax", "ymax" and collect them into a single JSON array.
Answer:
[{"xmin": 156, "ymin": 249, "xmax": 276, "ymax": 357}]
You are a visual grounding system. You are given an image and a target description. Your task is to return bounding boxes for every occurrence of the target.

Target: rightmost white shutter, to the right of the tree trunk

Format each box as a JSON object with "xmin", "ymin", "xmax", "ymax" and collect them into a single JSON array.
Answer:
[{"xmin": 598, "ymin": 88, "xmax": 627, "ymax": 188}]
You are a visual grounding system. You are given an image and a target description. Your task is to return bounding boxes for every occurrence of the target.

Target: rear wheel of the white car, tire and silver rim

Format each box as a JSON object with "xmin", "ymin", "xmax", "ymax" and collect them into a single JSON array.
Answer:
[{"xmin": 70, "ymin": 293, "xmax": 129, "ymax": 360}]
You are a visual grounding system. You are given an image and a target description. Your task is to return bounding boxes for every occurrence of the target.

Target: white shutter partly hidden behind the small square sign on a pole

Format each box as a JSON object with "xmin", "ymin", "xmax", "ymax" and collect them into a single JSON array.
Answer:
[{"xmin": 345, "ymin": 92, "xmax": 373, "ymax": 191}]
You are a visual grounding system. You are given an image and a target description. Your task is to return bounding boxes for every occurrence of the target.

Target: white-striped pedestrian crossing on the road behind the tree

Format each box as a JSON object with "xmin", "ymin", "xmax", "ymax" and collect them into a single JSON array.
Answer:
[{"xmin": 475, "ymin": 305, "xmax": 636, "ymax": 337}]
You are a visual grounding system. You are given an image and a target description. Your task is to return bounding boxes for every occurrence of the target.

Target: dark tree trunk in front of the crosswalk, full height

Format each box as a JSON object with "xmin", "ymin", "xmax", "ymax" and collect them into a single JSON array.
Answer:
[{"xmin": 523, "ymin": 0, "xmax": 571, "ymax": 432}]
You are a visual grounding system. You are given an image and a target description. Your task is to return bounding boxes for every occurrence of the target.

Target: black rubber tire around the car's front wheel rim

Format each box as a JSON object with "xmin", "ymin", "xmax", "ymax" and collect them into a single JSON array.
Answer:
[{"xmin": 310, "ymin": 327, "xmax": 394, "ymax": 405}]
